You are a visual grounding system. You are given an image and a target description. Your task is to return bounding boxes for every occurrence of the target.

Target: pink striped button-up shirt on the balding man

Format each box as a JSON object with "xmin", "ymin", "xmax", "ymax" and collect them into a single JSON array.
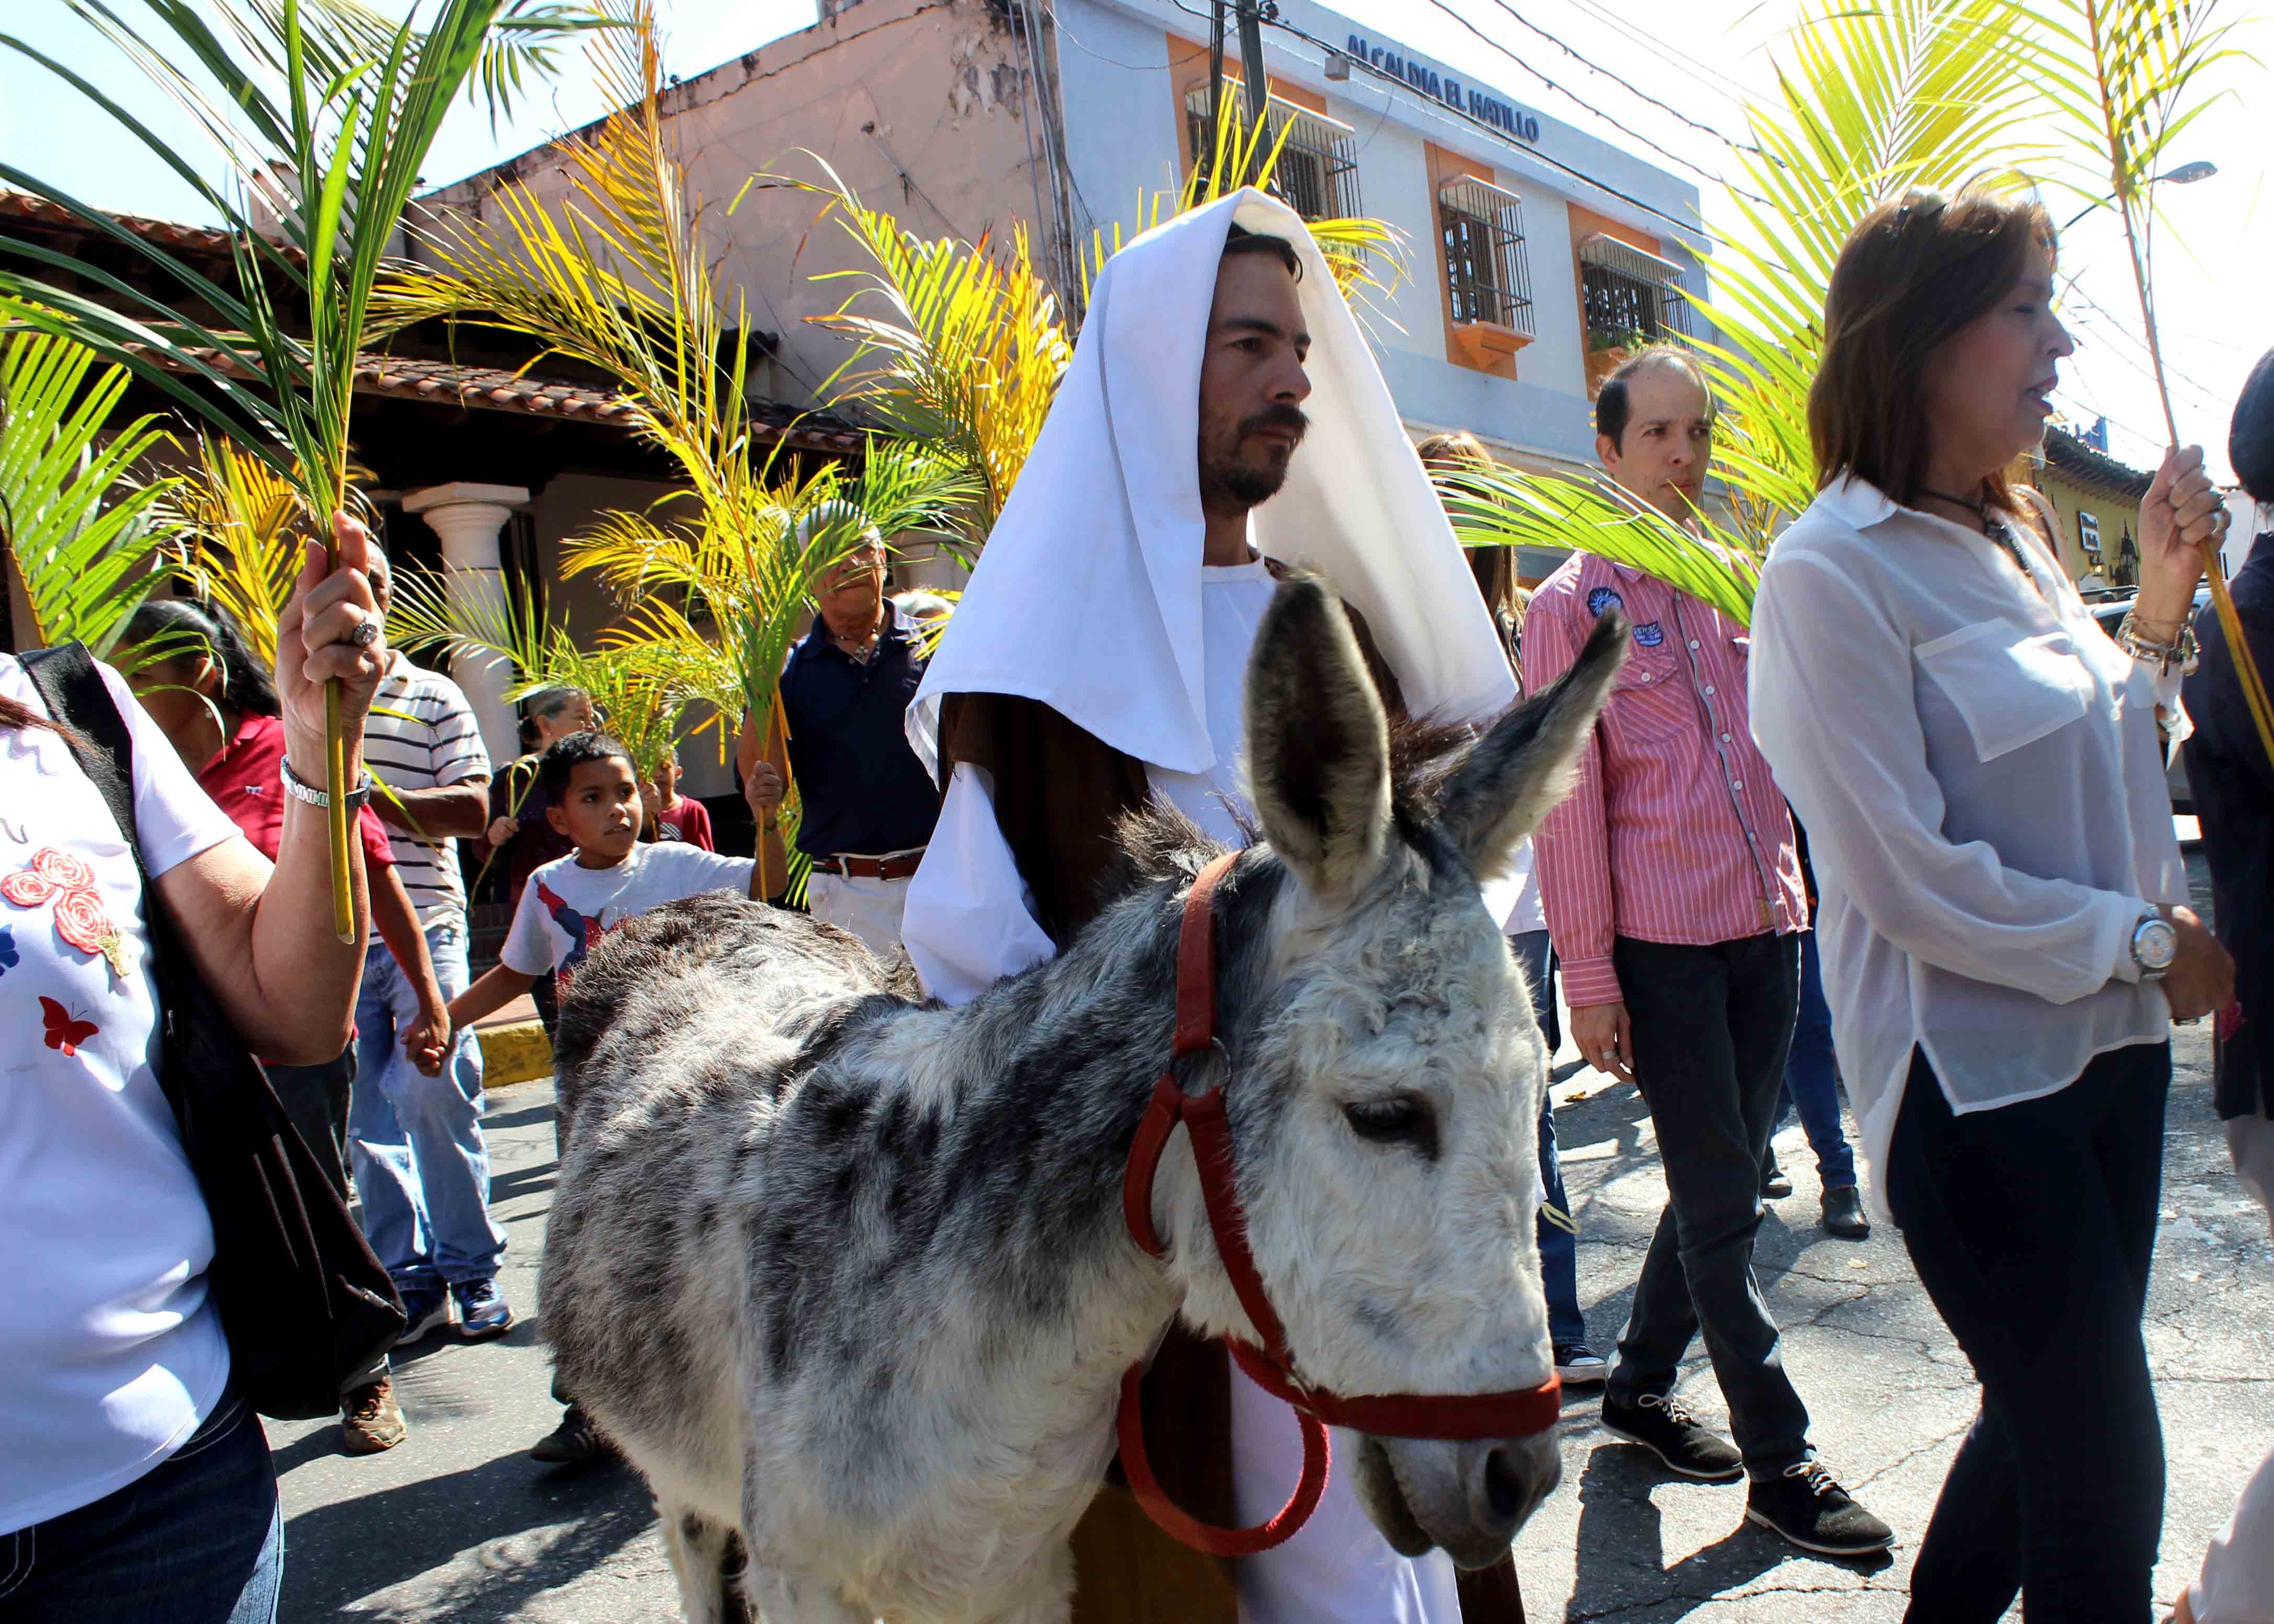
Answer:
[{"xmin": 1523, "ymin": 553, "xmax": 1808, "ymax": 1007}]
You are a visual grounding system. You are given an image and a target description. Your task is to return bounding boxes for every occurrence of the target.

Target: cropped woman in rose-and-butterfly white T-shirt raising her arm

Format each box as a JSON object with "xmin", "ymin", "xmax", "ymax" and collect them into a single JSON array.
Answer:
[{"xmin": 0, "ymin": 521, "xmax": 387, "ymax": 1624}]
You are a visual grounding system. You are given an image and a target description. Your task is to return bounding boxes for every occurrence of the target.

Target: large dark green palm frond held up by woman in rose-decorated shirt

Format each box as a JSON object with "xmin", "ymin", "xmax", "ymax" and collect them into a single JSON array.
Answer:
[{"xmin": 0, "ymin": 0, "xmax": 598, "ymax": 939}]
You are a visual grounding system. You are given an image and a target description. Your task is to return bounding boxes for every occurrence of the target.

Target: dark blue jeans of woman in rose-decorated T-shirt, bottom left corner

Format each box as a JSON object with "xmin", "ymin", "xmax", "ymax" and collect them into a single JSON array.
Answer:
[{"xmin": 0, "ymin": 1392, "xmax": 284, "ymax": 1624}]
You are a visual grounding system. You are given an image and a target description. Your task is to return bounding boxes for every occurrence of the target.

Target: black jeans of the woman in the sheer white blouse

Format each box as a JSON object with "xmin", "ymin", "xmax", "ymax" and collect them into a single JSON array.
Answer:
[{"xmin": 1887, "ymin": 1044, "xmax": 2172, "ymax": 1624}]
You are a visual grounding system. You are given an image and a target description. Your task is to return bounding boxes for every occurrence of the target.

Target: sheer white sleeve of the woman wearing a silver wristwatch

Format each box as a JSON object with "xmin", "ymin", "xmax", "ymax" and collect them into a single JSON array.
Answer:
[{"xmin": 1751, "ymin": 557, "xmax": 2142, "ymax": 1003}]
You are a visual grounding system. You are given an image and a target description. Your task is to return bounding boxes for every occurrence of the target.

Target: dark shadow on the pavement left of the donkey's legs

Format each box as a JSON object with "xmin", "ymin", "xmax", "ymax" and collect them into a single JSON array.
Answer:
[{"xmin": 278, "ymin": 1440, "xmax": 655, "ymax": 1624}]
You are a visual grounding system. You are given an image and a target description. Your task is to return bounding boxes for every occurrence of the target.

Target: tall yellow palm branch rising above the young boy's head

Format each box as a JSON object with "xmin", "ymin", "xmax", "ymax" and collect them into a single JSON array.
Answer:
[{"xmin": 380, "ymin": 5, "xmax": 978, "ymax": 782}]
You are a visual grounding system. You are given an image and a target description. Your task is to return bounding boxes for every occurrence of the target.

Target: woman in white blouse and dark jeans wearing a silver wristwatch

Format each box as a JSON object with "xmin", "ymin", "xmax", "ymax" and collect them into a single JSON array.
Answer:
[{"xmin": 1751, "ymin": 193, "xmax": 2233, "ymax": 1624}]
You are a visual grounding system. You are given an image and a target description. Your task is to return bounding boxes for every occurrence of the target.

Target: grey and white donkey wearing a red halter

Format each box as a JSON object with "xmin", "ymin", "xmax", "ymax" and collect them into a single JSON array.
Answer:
[{"xmin": 544, "ymin": 580, "xmax": 1624, "ymax": 1624}]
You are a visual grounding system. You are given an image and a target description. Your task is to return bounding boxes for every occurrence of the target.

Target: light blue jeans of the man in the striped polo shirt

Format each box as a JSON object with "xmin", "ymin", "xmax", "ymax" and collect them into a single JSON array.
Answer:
[{"xmin": 348, "ymin": 923, "xmax": 505, "ymax": 1296}]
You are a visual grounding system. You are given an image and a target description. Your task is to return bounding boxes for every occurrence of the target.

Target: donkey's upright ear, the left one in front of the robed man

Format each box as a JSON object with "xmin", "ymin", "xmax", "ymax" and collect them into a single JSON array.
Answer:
[{"xmin": 1249, "ymin": 575, "xmax": 1389, "ymax": 898}]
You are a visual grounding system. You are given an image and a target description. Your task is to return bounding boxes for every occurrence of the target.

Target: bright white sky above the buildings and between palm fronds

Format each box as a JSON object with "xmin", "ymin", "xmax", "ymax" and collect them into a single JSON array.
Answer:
[{"xmin": 0, "ymin": 0, "xmax": 2274, "ymax": 478}]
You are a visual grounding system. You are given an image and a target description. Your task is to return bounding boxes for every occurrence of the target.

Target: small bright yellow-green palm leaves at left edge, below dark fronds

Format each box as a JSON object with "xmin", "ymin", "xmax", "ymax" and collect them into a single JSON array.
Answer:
[{"xmin": 0, "ymin": 332, "xmax": 168, "ymax": 664}]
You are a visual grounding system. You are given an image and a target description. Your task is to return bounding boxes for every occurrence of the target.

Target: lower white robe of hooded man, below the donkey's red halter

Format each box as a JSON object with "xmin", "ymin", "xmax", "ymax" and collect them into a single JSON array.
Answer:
[{"xmin": 1232, "ymin": 1365, "xmax": 1460, "ymax": 1624}]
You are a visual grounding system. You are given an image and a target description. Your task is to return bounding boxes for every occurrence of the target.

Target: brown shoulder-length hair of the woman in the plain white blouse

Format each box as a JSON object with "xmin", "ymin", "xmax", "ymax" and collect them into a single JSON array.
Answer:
[{"xmin": 1808, "ymin": 191, "xmax": 2053, "ymax": 507}]
